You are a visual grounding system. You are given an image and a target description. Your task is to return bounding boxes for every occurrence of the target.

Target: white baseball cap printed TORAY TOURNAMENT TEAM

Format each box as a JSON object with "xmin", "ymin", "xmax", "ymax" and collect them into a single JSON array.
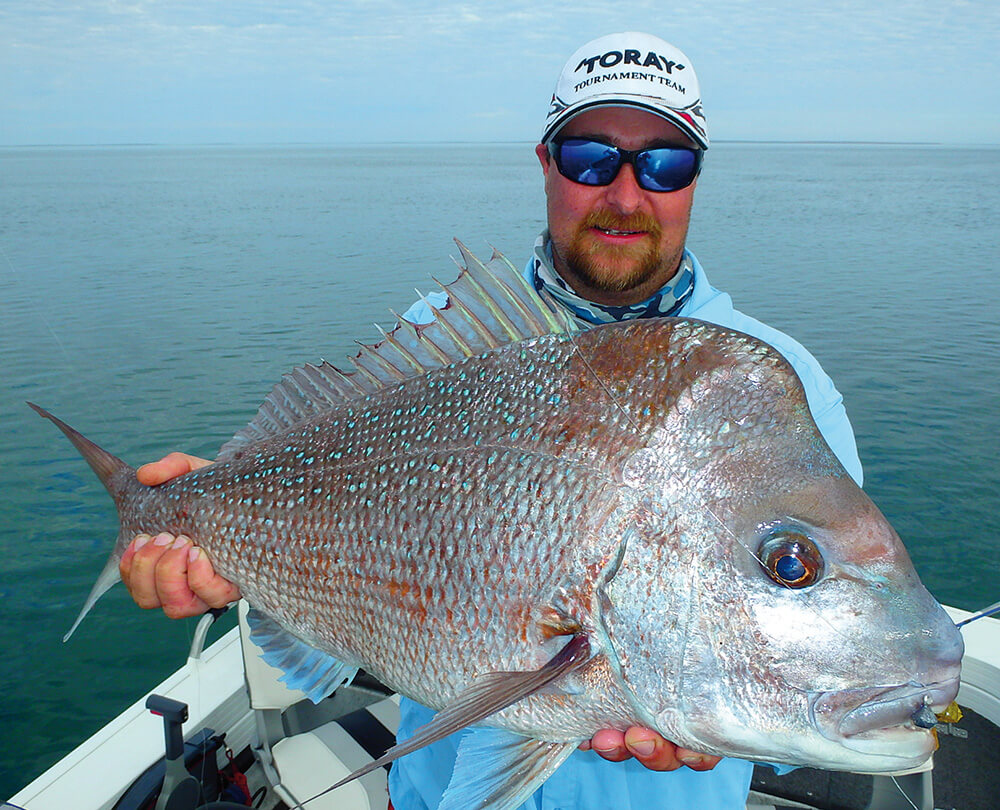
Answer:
[{"xmin": 542, "ymin": 31, "xmax": 708, "ymax": 149}]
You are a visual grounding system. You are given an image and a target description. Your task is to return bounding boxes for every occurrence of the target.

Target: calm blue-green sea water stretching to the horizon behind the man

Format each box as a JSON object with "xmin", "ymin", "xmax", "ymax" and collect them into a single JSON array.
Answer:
[{"xmin": 0, "ymin": 143, "xmax": 1000, "ymax": 798}]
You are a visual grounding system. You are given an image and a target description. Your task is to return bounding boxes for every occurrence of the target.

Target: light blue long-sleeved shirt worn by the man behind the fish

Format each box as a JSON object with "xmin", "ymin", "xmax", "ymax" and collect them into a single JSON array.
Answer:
[{"xmin": 389, "ymin": 246, "xmax": 862, "ymax": 810}]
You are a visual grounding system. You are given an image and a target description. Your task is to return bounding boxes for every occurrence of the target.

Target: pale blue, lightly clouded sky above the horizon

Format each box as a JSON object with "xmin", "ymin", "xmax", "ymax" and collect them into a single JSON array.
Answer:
[{"xmin": 0, "ymin": 0, "xmax": 1000, "ymax": 146}]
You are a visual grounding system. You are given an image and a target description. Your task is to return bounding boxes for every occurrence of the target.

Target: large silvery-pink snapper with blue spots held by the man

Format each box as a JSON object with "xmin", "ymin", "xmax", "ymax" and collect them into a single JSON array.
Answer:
[{"xmin": 33, "ymin": 243, "xmax": 962, "ymax": 808}]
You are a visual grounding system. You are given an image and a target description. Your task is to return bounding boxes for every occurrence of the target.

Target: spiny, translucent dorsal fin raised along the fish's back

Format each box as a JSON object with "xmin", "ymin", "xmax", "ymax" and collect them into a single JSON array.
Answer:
[{"xmin": 217, "ymin": 239, "xmax": 577, "ymax": 460}]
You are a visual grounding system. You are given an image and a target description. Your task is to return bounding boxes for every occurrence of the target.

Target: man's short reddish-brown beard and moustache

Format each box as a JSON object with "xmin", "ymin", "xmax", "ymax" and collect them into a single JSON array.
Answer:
[{"xmin": 562, "ymin": 211, "xmax": 664, "ymax": 292}]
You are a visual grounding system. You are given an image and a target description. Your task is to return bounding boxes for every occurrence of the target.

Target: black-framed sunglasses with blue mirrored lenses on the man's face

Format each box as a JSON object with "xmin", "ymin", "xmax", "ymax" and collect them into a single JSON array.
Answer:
[{"xmin": 549, "ymin": 138, "xmax": 705, "ymax": 191}]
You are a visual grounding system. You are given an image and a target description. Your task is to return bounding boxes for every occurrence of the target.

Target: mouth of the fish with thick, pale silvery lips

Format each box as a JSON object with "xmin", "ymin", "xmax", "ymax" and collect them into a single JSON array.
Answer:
[{"xmin": 812, "ymin": 675, "xmax": 959, "ymax": 753}]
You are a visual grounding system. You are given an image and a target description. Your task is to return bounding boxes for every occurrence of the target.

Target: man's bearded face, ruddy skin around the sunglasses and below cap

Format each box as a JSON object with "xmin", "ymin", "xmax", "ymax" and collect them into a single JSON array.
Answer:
[{"xmin": 535, "ymin": 107, "xmax": 695, "ymax": 305}]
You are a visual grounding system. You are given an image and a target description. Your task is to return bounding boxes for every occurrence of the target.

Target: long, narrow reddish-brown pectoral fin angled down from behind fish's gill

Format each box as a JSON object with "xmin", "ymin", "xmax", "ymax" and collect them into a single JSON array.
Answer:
[{"xmin": 293, "ymin": 635, "xmax": 590, "ymax": 810}]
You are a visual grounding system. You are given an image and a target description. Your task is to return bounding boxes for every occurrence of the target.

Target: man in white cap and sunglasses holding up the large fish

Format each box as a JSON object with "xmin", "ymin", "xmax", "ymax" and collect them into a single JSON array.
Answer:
[{"xmin": 121, "ymin": 33, "xmax": 861, "ymax": 810}]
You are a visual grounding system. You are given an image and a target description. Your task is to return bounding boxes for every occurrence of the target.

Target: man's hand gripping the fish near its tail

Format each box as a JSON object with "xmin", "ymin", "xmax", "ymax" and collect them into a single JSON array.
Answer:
[{"xmin": 118, "ymin": 453, "xmax": 240, "ymax": 619}]
